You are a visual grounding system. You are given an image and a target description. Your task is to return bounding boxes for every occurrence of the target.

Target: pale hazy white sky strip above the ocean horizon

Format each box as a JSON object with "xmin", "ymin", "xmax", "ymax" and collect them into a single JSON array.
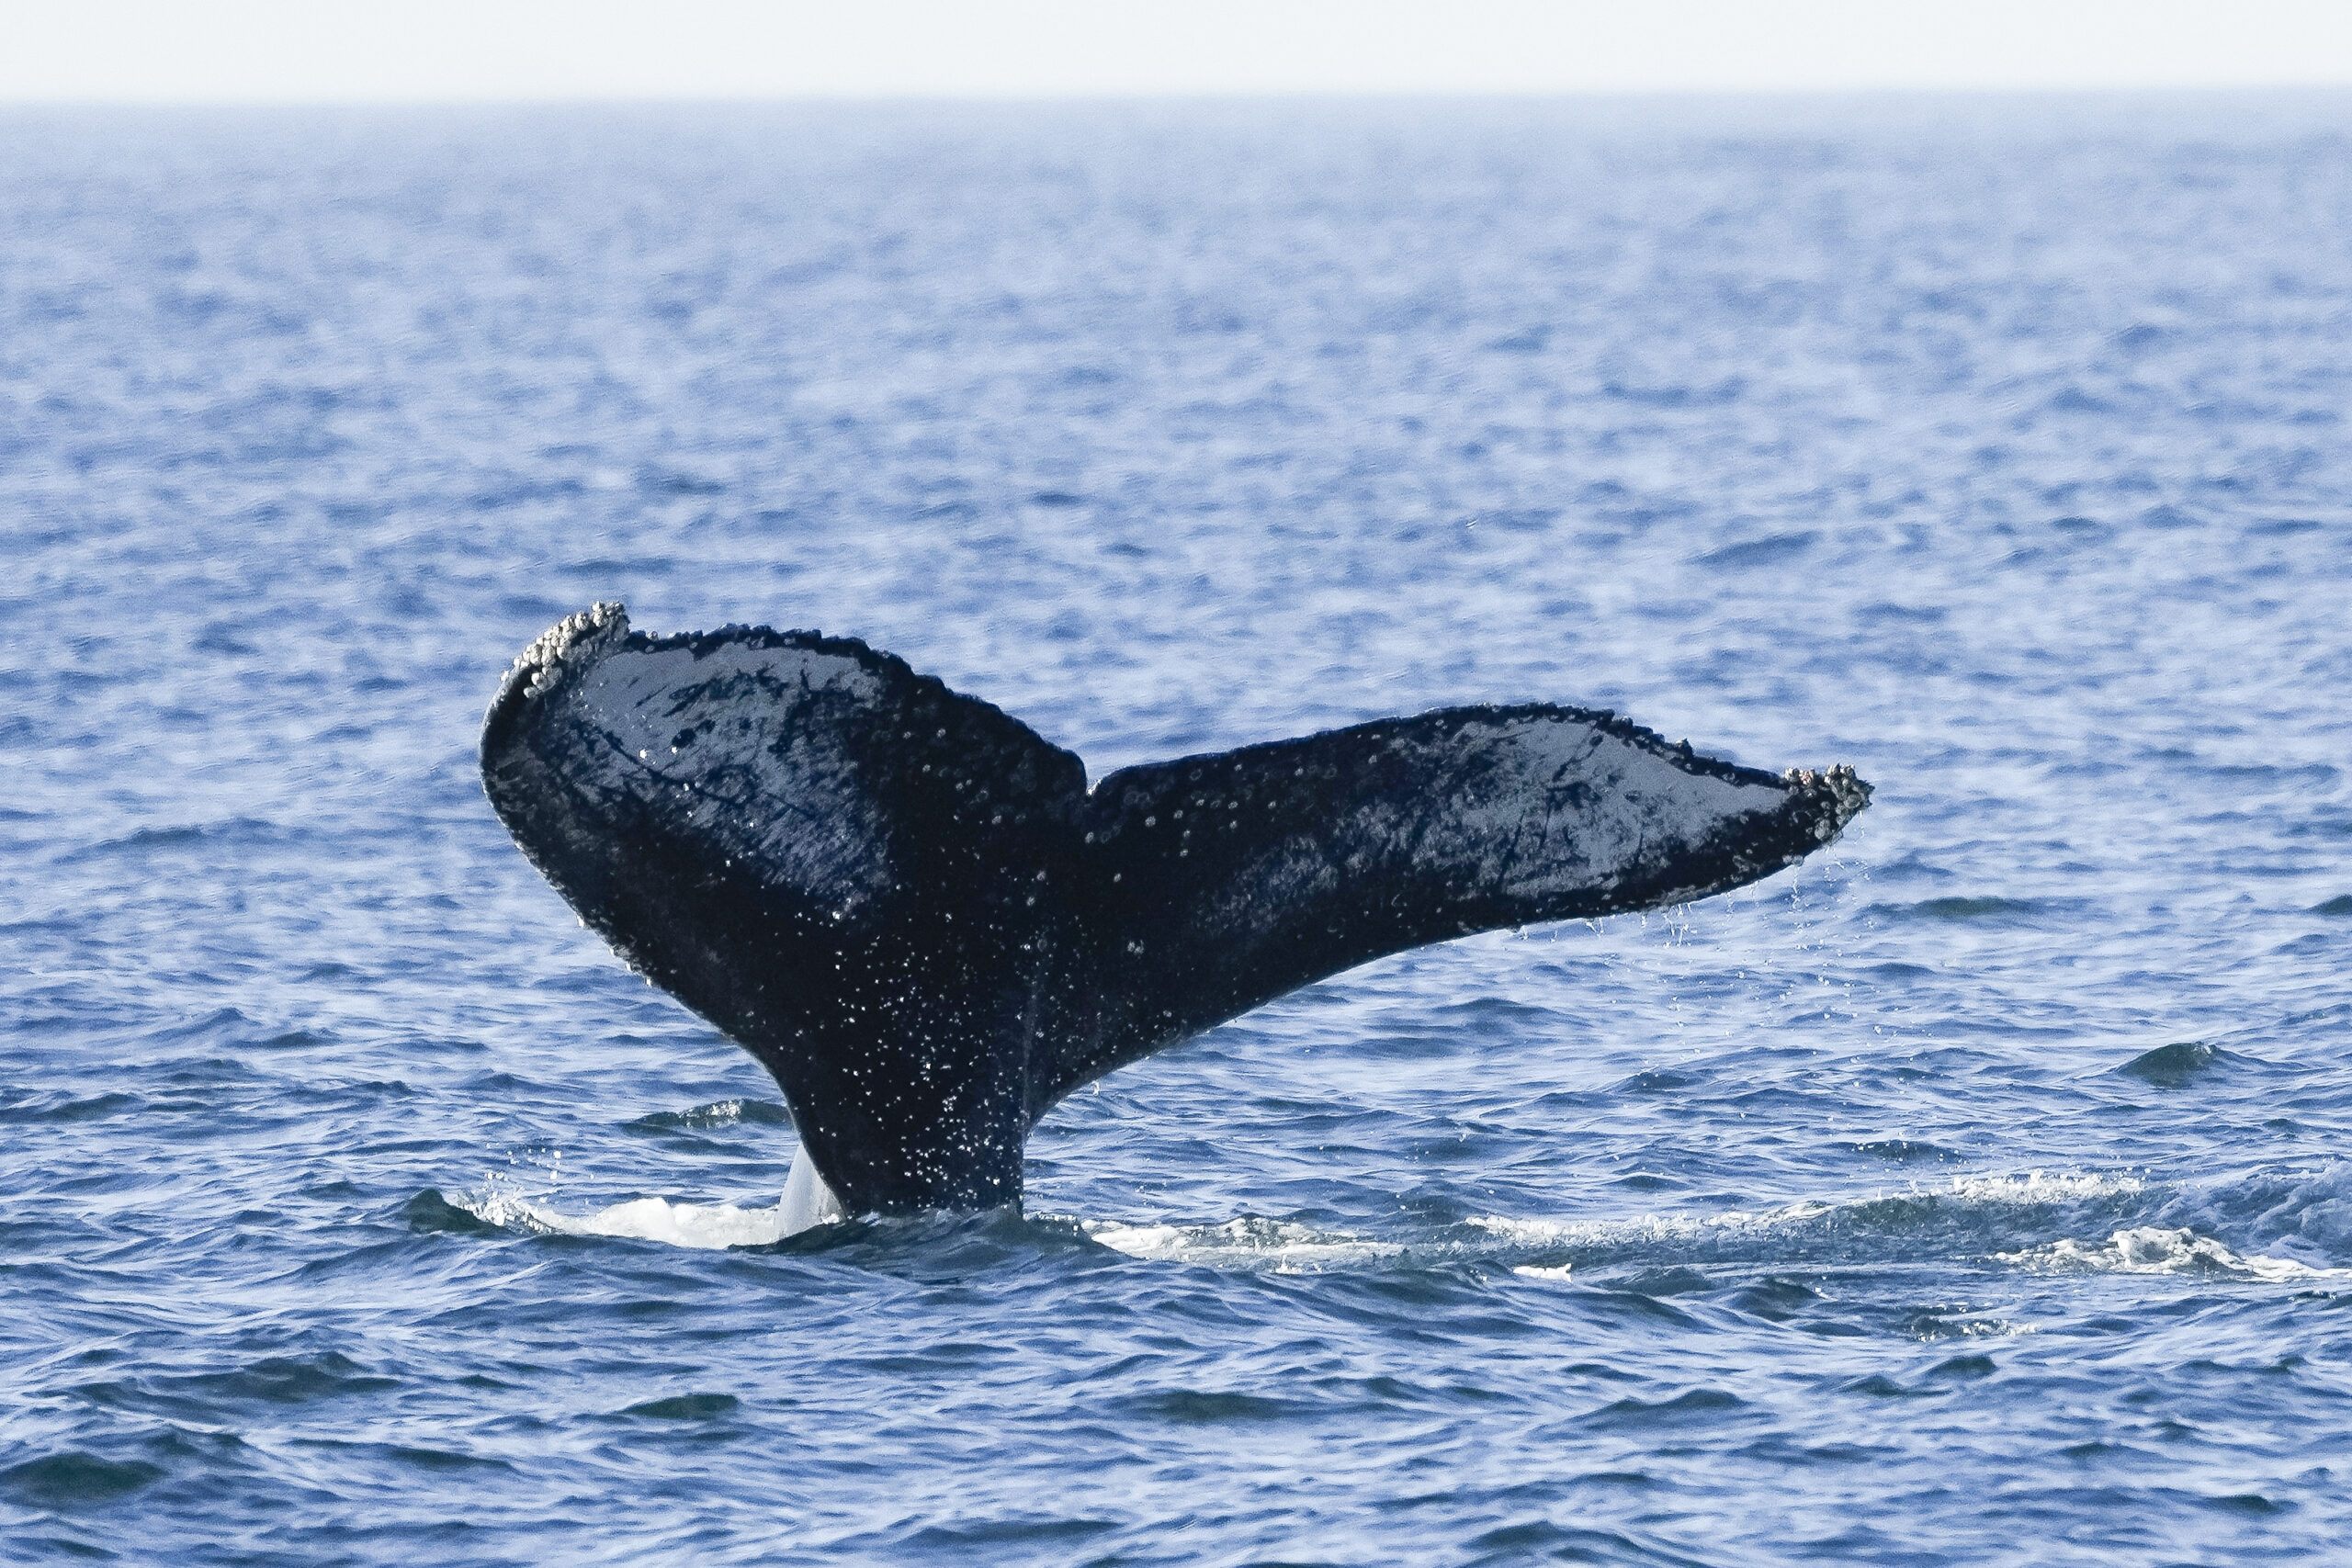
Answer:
[{"xmin": 0, "ymin": 0, "xmax": 2352, "ymax": 104}]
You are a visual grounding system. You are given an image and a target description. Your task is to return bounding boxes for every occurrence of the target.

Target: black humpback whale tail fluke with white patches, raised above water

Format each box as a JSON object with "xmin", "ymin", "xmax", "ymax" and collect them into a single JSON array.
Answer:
[{"xmin": 482, "ymin": 604, "xmax": 1870, "ymax": 1213}]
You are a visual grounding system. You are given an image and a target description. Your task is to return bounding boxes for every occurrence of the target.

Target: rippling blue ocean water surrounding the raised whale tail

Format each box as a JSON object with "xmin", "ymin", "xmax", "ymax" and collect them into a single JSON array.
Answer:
[{"xmin": 0, "ymin": 96, "xmax": 2352, "ymax": 1565}]
